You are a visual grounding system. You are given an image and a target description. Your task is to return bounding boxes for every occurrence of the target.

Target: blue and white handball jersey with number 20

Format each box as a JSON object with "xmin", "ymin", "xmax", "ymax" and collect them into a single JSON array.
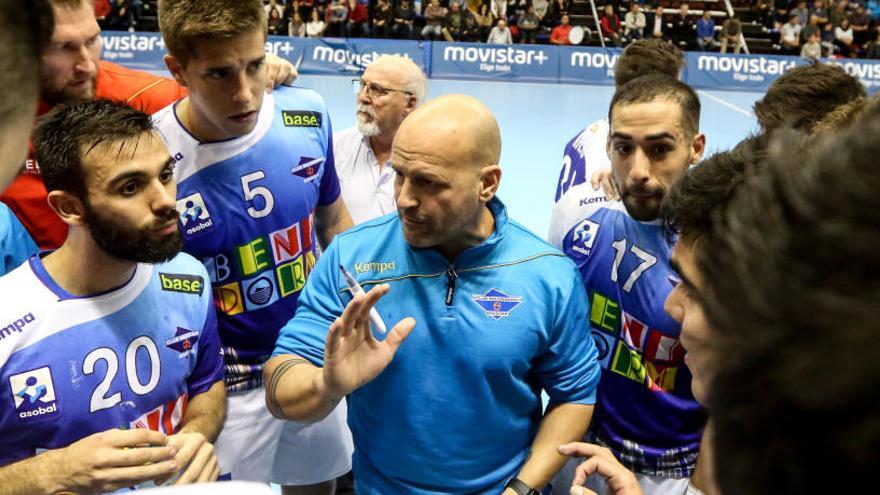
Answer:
[{"xmin": 0, "ymin": 254, "xmax": 223, "ymax": 465}]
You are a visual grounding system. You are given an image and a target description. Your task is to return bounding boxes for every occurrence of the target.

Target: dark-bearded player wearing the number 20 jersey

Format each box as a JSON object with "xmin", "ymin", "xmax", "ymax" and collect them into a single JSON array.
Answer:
[{"xmin": 0, "ymin": 100, "xmax": 226, "ymax": 494}]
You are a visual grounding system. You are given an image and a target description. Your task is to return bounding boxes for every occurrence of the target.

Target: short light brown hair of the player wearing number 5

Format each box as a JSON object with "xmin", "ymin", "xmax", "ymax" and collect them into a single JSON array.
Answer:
[{"xmin": 159, "ymin": 0, "xmax": 268, "ymax": 65}]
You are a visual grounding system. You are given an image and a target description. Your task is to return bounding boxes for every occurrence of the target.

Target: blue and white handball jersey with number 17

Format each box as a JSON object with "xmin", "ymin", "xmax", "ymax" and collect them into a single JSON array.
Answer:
[{"xmin": 549, "ymin": 182, "xmax": 705, "ymax": 478}]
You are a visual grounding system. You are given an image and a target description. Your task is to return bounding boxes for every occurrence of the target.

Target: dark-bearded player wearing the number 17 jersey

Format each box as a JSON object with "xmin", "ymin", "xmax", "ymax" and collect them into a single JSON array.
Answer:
[{"xmin": 550, "ymin": 75, "xmax": 705, "ymax": 493}]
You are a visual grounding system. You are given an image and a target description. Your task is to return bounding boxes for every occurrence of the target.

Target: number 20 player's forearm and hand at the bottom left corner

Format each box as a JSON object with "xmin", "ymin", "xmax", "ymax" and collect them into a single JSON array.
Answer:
[{"xmin": 0, "ymin": 429, "xmax": 178, "ymax": 495}]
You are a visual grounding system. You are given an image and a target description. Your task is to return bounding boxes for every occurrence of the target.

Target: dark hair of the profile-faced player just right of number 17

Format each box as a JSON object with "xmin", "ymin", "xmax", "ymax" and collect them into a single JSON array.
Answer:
[{"xmin": 660, "ymin": 134, "xmax": 768, "ymax": 247}]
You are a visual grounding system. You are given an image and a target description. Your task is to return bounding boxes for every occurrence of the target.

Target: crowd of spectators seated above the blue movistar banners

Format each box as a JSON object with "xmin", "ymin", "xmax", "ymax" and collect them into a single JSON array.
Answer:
[{"xmin": 95, "ymin": 0, "xmax": 880, "ymax": 59}]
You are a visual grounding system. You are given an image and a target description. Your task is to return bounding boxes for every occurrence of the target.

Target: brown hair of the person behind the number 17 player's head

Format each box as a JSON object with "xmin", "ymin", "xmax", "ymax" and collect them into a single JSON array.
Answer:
[{"xmin": 614, "ymin": 38, "xmax": 685, "ymax": 87}]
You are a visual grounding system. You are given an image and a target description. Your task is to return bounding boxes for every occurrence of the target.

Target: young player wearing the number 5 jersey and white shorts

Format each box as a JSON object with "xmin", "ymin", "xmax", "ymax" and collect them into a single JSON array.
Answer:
[{"xmin": 154, "ymin": 0, "xmax": 352, "ymax": 493}]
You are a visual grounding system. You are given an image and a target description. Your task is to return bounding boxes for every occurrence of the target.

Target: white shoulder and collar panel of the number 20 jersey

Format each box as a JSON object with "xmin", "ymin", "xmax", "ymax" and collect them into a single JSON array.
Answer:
[{"xmin": 0, "ymin": 262, "xmax": 153, "ymax": 366}]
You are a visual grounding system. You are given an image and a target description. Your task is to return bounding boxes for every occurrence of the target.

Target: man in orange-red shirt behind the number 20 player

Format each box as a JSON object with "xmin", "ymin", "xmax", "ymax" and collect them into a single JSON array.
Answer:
[{"xmin": 0, "ymin": 0, "xmax": 296, "ymax": 249}]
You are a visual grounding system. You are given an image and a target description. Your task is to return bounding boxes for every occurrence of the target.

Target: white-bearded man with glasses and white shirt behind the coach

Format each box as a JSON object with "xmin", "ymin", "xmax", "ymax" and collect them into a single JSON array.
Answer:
[{"xmin": 333, "ymin": 55, "xmax": 428, "ymax": 224}]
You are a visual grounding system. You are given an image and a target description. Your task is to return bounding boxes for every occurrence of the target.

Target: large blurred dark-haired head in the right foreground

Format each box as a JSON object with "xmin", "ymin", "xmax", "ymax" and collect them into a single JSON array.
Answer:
[{"xmin": 702, "ymin": 105, "xmax": 880, "ymax": 495}]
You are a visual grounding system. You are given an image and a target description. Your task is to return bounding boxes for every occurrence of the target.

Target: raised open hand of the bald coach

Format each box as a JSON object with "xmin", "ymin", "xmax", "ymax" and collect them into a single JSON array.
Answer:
[{"xmin": 324, "ymin": 285, "xmax": 416, "ymax": 398}]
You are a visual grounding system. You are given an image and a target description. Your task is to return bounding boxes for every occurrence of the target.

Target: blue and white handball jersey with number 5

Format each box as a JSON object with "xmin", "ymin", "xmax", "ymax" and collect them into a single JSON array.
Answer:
[{"xmin": 153, "ymin": 87, "xmax": 339, "ymax": 390}]
